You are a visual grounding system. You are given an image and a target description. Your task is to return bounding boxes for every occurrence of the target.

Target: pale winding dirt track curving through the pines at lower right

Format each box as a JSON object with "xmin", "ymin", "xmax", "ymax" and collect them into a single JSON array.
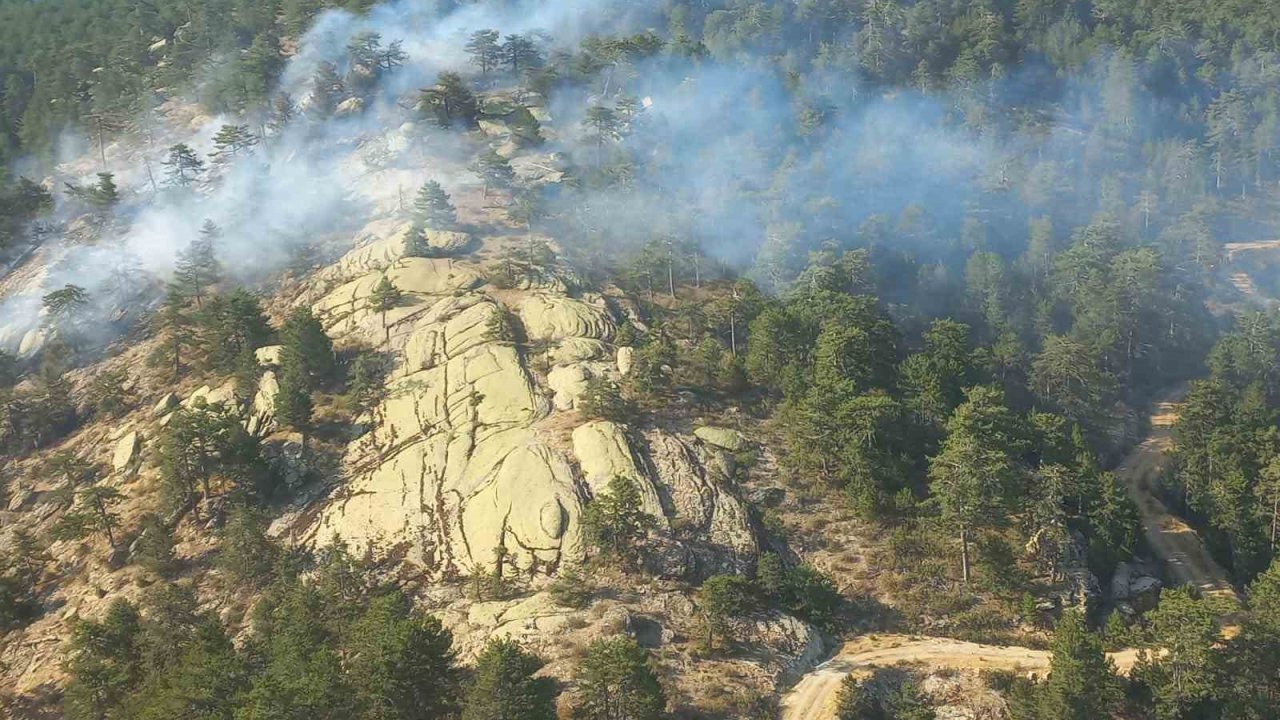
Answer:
[{"xmin": 782, "ymin": 387, "xmax": 1240, "ymax": 720}]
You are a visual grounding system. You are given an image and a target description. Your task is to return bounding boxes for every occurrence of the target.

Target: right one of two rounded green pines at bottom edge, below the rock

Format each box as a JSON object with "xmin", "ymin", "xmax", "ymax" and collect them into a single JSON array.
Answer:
[{"xmin": 573, "ymin": 637, "xmax": 667, "ymax": 720}]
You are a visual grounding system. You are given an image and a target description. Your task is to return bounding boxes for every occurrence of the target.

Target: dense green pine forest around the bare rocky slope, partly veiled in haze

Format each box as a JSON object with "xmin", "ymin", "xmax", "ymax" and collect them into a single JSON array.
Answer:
[{"xmin": 0, "ymin": 0, "xmax": 1280, "ymax": 720}]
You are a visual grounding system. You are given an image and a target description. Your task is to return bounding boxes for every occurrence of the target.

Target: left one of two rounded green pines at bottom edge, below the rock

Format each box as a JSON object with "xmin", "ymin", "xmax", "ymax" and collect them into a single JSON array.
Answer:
[{"xmin": 462, "ymin": 638, "xmax": 556, "ymax": 720}]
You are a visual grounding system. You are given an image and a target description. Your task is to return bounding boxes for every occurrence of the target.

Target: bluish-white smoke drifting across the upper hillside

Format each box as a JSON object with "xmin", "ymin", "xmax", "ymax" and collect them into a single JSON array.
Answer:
[{"xmin": 0, "ymin": 0, "xmax": 1228, "ymax": 348}]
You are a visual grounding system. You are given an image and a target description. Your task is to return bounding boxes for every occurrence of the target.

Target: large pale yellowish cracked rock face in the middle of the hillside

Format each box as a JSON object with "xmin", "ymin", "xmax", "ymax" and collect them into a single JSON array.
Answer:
[{"xmin": 300, "ymin": 223, "xmax": 754, "ymax": 579}]
